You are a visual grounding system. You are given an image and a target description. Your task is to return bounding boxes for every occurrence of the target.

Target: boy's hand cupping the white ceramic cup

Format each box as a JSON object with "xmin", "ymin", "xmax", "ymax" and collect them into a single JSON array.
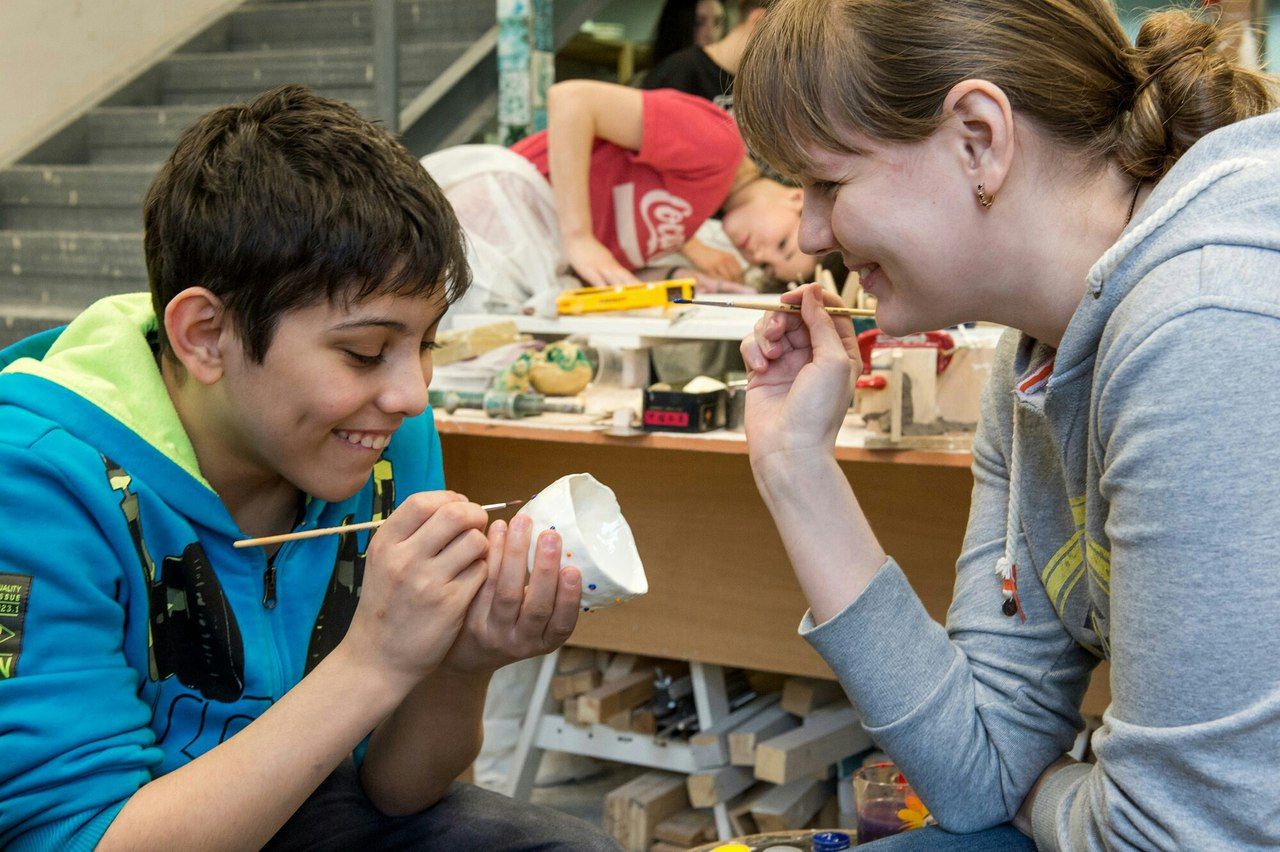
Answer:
[{"xmin": 442, "ymin": 514, "xmax": 582, "ymax": 674}]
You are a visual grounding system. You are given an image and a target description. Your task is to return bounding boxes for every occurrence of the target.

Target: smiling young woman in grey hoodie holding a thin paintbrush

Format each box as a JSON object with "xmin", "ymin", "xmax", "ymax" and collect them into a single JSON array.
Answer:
[{"xmin": 735, "ymin": 0, "xmax": 1280, "ymax": 849}]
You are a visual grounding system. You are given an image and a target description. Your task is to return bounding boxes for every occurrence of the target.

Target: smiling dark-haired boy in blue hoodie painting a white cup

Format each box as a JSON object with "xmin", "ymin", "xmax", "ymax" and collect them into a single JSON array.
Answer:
[{"xmin": 0, "ymin": 86, "xmax": 612, "ymax": 849}]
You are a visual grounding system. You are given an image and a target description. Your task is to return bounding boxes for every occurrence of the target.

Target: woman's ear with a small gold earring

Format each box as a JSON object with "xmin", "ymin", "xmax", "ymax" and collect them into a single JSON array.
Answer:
[{"xmin": 942, "ymin": 79, "xmax": 1014, "ymax": 198}]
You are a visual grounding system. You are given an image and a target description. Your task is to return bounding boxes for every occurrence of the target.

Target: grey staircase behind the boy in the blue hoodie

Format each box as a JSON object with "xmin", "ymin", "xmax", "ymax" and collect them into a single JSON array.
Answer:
[{"xmin": 0, "ymin": 0, "xmax": 576, "ymax": 347}]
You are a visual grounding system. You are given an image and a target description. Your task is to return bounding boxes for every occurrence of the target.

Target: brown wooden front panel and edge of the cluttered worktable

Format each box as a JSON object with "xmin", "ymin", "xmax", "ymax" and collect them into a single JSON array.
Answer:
[{"xmin": 436, "ymin": 412, "xmax": 1110, "ymax": 713}]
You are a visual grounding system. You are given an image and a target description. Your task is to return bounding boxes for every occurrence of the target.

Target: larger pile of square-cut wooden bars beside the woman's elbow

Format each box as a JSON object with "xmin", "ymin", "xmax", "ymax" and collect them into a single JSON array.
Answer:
[{"xmin": 604, "ymin": 678, "xmax": 872, "ymax": 852}]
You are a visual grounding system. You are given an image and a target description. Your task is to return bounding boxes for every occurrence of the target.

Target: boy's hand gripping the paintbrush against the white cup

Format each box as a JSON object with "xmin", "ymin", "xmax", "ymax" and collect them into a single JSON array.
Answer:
[{"xmin": 342, "ymin": 491, "xmax": 489, "ymax": 688}]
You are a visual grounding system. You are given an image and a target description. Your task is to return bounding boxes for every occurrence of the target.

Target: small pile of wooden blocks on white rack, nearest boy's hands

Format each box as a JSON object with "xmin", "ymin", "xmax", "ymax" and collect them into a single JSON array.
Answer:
[{"xmin": 552, "ymin": 647, "xmax": 665, "ymax": 734}]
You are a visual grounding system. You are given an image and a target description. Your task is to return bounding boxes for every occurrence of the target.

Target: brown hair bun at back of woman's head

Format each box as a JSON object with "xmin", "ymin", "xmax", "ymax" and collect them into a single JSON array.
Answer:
[{"xmin": 1116, "ymin": 12, "xmax": 1270, "ymax": 179}]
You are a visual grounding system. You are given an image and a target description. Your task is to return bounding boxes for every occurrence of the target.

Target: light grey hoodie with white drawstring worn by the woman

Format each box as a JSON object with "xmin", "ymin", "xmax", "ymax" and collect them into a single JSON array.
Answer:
[{"xmin": 800, "ymin": 114, "xmax": 1280, "ymax": 849}]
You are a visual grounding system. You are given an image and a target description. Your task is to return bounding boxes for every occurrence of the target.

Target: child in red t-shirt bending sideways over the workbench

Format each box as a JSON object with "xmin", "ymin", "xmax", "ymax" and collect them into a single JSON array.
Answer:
[{"xmin": 422, "ymin": 81, "xmax": 814, "ymax": 319}]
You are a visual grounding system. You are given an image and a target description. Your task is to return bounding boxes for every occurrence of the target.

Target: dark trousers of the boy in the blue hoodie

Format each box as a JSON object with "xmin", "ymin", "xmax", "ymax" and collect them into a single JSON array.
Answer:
[{"xmin": 264, "ymin": 760, "xmax": 618, "ymax": 852}]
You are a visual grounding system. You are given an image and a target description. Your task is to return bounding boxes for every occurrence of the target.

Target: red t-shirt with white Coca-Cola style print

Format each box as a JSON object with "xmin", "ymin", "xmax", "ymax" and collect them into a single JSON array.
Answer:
[{"xmin": 511, "ymin": 88, "xmax": 746, "ymax": 270}]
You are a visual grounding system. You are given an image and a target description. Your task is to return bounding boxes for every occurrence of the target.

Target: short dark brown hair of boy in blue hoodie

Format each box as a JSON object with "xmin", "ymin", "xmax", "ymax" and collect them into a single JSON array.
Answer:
[{"xmin": 143, "ymin": 79, "xmax": 471, "ymax": 362}]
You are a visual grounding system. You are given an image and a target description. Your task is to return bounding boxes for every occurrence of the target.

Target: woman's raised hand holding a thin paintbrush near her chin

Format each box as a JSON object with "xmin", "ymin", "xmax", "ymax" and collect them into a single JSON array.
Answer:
[{"xmin": 741, "ymin": 284, "xmax": 861, "ymax": 476}]
